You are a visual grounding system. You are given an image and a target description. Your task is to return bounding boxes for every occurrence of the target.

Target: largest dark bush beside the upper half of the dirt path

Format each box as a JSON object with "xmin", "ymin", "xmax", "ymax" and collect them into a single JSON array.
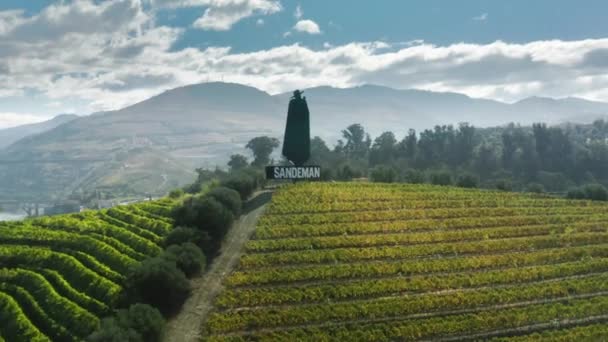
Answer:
[{"xmin": 173, "ymin": 195, "xmax": 234, "ymax": 239}]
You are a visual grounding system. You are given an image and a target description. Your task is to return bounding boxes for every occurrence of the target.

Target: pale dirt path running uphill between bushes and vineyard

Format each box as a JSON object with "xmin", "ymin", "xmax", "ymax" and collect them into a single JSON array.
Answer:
[{"xmin": 164, "ymin": 192, "xmax": 270, "ymax": 342}]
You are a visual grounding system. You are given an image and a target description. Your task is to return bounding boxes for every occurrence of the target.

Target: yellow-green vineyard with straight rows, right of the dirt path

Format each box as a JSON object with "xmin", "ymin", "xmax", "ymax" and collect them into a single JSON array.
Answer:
[{"xmin": 203, "ymin": 183, "xmax": 608, "ymax": 341}]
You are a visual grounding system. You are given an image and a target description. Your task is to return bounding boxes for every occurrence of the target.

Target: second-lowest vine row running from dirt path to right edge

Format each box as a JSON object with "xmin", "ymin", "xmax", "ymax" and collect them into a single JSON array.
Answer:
[{"xmin": 207, "ymin": 274, "xmax": 608, "ymax": 334}]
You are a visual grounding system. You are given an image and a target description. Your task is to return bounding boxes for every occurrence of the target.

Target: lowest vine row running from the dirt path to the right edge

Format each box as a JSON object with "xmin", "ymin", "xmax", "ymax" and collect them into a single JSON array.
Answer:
[{"xmin": 207, "ymin": 296, "xmax": 608, "ymax": 342}]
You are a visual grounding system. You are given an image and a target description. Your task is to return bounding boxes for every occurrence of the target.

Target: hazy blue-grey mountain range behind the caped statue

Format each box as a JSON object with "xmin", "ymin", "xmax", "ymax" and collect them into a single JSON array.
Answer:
[{"xmin": 0, "ymin": 82, "xmax": 608, "ymax": 199}]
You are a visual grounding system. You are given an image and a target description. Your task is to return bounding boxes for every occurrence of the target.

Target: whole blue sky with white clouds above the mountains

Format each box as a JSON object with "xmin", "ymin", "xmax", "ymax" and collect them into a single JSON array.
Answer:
[{"xmin": 0, "ymin": 0, "xmax": 608, "ymax": 128}]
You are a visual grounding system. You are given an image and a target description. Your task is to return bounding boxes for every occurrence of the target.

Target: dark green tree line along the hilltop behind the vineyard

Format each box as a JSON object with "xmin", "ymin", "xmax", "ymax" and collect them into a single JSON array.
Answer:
[{"xmin": 228, "ymin": 120, "xmax": 608, "ymax": 197}]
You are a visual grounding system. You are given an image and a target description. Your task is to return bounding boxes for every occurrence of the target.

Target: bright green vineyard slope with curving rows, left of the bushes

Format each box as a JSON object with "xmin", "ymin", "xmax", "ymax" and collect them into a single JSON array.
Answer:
[{"xmin": 0, "ymin": 199, "xmax": 174, "ymax": 341}]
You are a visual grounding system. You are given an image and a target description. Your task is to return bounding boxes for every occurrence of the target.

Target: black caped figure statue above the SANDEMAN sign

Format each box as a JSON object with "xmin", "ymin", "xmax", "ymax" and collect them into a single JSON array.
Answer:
[{"xmin": 283, "ymin": 90, "xmax": 310, "ymax": 166}]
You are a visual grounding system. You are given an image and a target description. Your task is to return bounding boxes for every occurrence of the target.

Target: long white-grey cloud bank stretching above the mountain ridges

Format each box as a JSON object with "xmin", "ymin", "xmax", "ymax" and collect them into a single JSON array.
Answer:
[{"xmin": 0, "ymin": 0, "xmax": 608, "ymax": 116}]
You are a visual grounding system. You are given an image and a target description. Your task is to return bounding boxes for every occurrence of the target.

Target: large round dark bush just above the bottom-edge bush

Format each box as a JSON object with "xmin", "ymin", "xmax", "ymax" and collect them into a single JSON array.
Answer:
[{"xmin": 124, "ymin": 257, "xmax": 190, "ymax": 314}]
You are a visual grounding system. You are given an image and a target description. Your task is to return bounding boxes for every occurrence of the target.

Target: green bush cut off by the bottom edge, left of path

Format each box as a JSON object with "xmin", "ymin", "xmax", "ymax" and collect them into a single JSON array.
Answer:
[{"xmin": 88, "ymin": 303, "xmax": 165, "ymax": 342}]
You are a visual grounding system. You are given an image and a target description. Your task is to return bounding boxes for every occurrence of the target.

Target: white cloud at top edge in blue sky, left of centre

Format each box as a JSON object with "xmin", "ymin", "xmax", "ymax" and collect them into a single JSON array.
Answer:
[{"xmin": 151, "ymin": 0, "xmax": 282, "ymax": 31}]
